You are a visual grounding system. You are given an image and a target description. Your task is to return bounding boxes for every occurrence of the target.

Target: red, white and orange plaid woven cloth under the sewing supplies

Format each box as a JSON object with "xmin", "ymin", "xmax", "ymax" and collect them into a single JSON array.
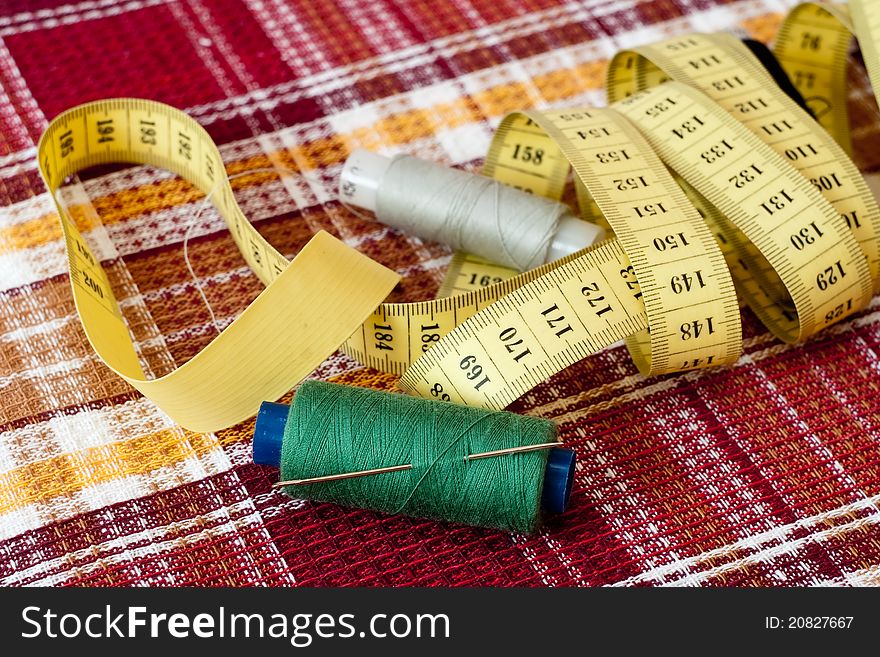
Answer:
[{"xmin": 0, "ymin": 0, "xmax": 880, "ymax": 586}]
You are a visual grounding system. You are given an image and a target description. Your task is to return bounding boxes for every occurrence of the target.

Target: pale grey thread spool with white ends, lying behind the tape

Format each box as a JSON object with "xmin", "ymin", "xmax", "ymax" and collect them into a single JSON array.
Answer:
[{"xmin": 339, "ymin": 148, "xmax": 605, "ymax": 271}]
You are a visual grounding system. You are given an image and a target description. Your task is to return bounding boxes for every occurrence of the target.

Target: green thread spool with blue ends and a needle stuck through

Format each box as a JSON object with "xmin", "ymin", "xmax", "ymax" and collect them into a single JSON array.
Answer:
[{"xmin": 254, "ymin": 381, "xmax": 574, "ymax": 532}]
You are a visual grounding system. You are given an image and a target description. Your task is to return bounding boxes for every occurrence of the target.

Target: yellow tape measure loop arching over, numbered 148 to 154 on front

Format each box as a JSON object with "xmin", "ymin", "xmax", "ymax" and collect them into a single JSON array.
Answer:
[{"xmin": 486, "ymin": 109, "xmax": 741, "ymax": 380}]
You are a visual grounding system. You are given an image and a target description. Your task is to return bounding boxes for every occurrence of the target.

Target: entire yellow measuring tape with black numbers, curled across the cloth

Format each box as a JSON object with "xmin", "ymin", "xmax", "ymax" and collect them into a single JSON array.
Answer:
[{"xmin": 38, "ymin": 2, "xmax": 880, "ymax": 431}]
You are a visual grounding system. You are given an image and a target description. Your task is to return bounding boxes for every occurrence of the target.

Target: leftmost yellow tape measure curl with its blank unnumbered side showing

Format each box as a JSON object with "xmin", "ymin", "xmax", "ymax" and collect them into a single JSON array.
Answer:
[{"xmin": 37, "ymin": 99, "xmax": 398, "ymax": 431}]
